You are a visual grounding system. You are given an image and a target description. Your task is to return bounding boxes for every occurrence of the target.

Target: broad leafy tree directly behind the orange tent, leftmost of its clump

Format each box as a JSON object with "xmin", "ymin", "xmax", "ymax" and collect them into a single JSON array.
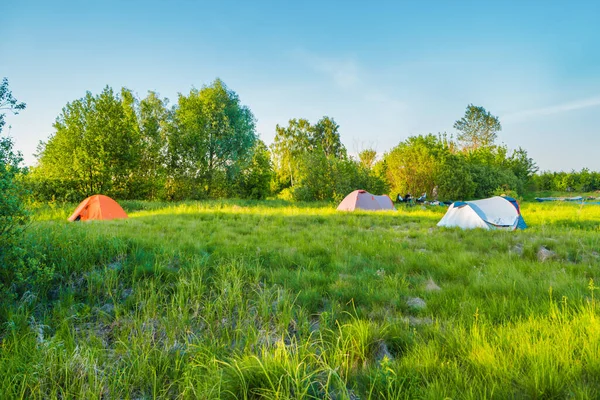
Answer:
[{"xmin": 35, "ymin": 87, "xmax": 141, "ymax": 197}]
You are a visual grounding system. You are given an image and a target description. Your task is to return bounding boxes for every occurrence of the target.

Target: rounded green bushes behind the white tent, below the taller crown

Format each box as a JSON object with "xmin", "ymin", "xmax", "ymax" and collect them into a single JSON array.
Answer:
[{"xmin": 380, "ymin": 134, "xmax": 537, "ymax": 200}]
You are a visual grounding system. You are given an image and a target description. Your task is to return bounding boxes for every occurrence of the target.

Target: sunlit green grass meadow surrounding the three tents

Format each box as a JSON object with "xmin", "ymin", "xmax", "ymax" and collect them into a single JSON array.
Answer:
[{"xmin": 0, "ymin": 201, "xmax": 600, "ymax": 399}]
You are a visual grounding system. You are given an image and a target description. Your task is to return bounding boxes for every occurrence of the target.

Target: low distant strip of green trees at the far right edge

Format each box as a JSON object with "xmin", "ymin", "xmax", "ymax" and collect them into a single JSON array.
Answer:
[{"xmin": 533, "ymin": 168, "xmax": 600, "ymax": 192}]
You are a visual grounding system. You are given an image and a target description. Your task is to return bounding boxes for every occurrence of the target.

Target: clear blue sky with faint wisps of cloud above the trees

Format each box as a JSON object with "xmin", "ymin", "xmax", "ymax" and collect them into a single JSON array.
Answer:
[{"xmin": 0, "ymin": 0, "xmax": 600, "ymax": 170}]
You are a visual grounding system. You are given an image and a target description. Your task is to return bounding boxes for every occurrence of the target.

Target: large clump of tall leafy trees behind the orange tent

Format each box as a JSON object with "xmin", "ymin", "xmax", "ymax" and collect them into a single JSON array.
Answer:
[{"xmin": 28, "ymin": 79, "xmax": 272, "ymax": 201}]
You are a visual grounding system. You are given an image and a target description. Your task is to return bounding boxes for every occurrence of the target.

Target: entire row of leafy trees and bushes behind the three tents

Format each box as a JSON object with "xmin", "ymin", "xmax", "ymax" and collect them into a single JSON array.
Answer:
[{"xmin": 26, "ymin": 79, "xmax": 537, "ymax": 202}]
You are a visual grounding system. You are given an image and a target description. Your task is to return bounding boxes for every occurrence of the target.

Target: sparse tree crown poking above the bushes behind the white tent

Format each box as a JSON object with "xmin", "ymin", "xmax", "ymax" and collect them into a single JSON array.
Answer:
[{"xmin": 454, "ymin": 104, "xmax": 502, "ymax": 151}]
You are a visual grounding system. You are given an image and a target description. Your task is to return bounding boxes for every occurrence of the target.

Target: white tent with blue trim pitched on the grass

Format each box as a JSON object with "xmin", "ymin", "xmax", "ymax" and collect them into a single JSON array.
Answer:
[{"xmin": 438, "ymin": 196, "xmax": 527, "ymax": 231}]
